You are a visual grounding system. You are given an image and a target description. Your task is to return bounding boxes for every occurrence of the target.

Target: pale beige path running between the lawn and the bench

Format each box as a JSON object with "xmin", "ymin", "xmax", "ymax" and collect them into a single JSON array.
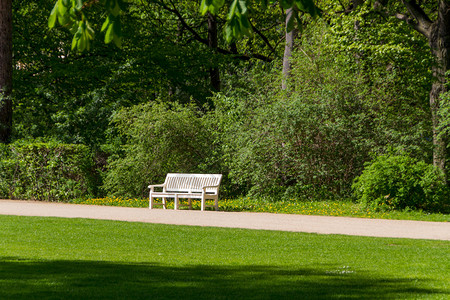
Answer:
[{"xmin": 0, "ymin": 200, "xmax": 450, "ymax": 241}]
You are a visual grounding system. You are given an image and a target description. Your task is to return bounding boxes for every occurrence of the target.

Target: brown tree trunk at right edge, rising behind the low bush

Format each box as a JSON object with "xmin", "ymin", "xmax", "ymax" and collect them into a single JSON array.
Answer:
[{"xmin": 429, "ymin": 1, "xmax": 450, "ymax": 176}]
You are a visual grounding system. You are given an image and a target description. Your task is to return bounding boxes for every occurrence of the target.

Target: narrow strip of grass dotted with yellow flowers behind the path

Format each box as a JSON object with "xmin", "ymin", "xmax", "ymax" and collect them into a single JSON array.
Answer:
[{"xmin": 73, "ymin": 197, "xmax": 450, "ymax": 222}]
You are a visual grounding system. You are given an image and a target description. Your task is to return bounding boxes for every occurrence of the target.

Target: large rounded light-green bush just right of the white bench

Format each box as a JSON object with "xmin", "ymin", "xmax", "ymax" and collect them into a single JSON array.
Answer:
[{"xmin": 215, "ymin": 49, "xmax": 381, "ymax": 200}]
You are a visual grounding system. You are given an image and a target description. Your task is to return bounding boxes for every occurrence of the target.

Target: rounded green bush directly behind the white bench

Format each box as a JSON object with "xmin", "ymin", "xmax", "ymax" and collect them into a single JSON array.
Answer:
[{"xmin": 105, "ymin": 102, "xmax": 220, "ymax": 197}]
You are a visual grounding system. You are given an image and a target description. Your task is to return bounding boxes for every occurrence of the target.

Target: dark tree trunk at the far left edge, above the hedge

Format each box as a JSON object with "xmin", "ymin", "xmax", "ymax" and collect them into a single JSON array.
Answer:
[{"xmin": 0, "ymin": 0, "xmax": 12, "ymax": 143}]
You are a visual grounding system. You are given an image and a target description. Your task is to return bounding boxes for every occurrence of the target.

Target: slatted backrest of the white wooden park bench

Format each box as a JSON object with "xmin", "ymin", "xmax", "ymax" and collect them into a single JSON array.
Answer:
[{"xmin": 165, "ymin": 173, "xmax": 222, "ymax": 194}]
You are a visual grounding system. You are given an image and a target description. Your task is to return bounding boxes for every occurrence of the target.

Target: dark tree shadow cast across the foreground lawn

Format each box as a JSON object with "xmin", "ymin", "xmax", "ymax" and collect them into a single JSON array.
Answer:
[{"xmin": 0, "ymin": 257, "xmax": 449, "ymax": 299}]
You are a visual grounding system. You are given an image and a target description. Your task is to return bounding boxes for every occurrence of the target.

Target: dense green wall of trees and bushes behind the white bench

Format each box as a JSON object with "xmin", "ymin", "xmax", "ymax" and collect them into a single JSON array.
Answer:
[{"xmin": 0, "ymin": 0, "xmax": 450, "ymax": 210}]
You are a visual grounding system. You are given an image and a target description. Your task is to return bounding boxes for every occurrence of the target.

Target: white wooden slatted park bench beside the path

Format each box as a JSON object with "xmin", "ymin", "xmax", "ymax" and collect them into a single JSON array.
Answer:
[{"xmin": 148, "ymin": 173, "xmax": 222, "ymax": 210}]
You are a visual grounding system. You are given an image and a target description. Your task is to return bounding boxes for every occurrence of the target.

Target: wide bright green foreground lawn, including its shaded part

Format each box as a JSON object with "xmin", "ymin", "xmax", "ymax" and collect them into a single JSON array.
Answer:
[{"xmin": 0, "ymin": 216, "xmax": 450, "ymax": 299}]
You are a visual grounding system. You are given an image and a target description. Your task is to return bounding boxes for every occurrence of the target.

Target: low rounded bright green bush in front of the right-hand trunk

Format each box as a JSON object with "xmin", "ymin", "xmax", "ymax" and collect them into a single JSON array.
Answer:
[{"xmin": 352, "ymin": 155, "xmax": 450, "ymax": 211}]
